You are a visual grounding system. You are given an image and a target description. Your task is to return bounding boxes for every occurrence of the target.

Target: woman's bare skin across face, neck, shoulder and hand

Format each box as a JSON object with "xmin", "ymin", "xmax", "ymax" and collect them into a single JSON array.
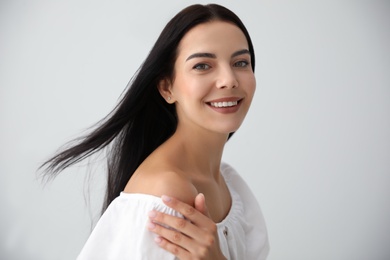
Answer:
[{"xmin": 124, "ymin": 21, "xmax": 256, "ymax": 260}]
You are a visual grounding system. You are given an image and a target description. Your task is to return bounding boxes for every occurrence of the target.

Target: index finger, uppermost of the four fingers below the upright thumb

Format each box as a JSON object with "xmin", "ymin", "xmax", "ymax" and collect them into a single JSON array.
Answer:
[{"xmin": 161, "ymin": 195, "xmax": 215, "ymax": 228}]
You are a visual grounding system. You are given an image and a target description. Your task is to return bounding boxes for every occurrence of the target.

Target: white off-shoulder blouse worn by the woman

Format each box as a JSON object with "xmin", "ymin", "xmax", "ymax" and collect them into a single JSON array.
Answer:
[{"xmin": 77, "ymin": 163, "xmax": 269, "ymax": 260}]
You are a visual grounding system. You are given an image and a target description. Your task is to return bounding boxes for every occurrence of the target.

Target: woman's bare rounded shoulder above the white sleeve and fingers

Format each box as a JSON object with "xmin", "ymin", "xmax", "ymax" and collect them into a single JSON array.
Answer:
[{"xmin": 124, "ymin": 167, "xmax": 198, "ymax": 205}]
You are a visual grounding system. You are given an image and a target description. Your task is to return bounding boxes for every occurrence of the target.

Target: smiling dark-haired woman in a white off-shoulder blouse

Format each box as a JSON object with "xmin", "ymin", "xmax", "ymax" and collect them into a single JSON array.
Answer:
[{"xmin": 42, "ymin": 5, "xmax": 268, "ymax": 260}]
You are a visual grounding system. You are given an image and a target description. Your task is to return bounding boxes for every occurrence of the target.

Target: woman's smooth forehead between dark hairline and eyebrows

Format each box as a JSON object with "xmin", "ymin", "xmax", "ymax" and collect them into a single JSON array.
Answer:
[{"xmin": 178, "ymin": 21, "xmax": 248, "ymax": 59}]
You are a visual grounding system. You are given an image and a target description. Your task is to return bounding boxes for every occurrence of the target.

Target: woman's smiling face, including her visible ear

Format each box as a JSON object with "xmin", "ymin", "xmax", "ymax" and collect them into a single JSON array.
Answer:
[{"xmin": 160, "ymin": 21, "xmax": 256, "ymax": 134}]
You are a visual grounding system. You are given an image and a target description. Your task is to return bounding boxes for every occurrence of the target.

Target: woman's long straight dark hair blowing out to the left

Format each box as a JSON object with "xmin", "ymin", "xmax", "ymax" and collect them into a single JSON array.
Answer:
[{"xmin": 41, "ymin": 4, "xmax": 255, "ymax": 211}]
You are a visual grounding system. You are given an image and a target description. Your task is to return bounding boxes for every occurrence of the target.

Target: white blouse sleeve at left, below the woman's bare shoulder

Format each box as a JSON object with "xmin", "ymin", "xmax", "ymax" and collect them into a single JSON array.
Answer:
[{"xmin": 77, "ymin": 193, "xmax": 183, "ymax": 260}]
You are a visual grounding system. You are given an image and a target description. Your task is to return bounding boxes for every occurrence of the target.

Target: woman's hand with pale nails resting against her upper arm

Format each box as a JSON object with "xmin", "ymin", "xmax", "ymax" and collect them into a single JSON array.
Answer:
[{"xmin": 148, "ymin": 193, "xmax": 226, "ymax": 260}]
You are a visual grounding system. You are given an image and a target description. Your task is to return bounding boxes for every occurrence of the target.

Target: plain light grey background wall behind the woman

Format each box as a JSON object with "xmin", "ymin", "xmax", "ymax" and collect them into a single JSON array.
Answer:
[{"xmin": 0, "ymin": 0, "xmax": 390, "ymax": 260}]
